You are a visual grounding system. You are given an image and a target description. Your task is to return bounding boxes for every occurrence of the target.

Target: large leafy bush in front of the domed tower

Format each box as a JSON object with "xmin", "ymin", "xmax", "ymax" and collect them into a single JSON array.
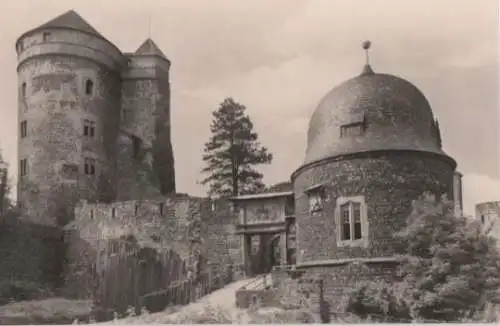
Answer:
[{"xmin": 347, "ymin": 194, "xmax": 500, "ymax": 322}]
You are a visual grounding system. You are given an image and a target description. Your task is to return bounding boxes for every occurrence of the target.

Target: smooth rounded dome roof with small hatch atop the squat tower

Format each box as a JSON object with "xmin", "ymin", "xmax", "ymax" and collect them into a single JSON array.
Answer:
[{"xmin": 304, "ymin": 65, "xmax": 444, "ymax": 164}]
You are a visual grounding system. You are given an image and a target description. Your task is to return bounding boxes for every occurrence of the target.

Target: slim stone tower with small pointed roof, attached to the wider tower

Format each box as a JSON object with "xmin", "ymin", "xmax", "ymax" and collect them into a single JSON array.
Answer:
[{"xmin": 118, "ymin": 38, "xmax": 175, "ymax": 200}]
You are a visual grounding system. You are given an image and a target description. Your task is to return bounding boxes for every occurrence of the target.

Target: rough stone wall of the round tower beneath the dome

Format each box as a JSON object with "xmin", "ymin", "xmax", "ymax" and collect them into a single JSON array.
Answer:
[{"xmin": 294, "ymin": 152, "xmax": 454, "ymax": 264}]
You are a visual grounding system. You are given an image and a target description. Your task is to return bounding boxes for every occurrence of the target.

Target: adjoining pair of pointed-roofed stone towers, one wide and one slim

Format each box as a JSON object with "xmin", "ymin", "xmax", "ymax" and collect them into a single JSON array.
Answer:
[{"xmin": 16, "ymin": 10, "xmax": 175, "ymax": 225}]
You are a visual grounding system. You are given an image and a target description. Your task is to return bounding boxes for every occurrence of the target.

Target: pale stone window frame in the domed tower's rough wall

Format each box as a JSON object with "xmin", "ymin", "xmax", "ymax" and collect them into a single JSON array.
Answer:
[{"xmin": 335, "ymin": 196, "xmax": 369, "ymax": 247}]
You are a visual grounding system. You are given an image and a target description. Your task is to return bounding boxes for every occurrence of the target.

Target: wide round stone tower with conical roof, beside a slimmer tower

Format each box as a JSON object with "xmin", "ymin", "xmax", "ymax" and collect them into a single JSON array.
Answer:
[{"xmin": 16, "ymin": 11, "xmax": 124, "ymax": 225}]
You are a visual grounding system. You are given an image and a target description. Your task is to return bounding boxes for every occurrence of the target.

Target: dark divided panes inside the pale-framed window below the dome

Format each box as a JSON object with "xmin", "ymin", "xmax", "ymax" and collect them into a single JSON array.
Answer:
[{"xmin": 339, "ymin": 201, "xmax": 363, "ymax": 241}]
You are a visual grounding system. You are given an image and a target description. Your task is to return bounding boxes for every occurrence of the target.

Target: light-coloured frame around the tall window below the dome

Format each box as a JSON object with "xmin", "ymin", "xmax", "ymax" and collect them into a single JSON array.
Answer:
[{"xmin": 335, "ymin": 196, "xmax": 369, "ymax": 247}]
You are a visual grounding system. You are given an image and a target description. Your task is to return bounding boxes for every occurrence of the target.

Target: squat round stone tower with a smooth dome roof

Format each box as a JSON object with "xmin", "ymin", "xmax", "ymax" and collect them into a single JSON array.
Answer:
[{"xmin": 292, "ymin": 43, "xmax": 456, "ymax": 304}]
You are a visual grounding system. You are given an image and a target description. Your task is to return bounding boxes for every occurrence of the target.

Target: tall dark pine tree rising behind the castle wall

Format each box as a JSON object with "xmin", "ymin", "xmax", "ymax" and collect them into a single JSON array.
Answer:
[{"xmin": 201, "ymin": 98, "xmax": 273, "ymax": 196}]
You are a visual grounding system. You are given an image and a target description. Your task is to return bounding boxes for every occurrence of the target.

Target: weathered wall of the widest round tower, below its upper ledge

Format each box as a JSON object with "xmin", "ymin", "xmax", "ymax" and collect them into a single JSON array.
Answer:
[{"xmin": 19, "ymin": 51, "xmax": 120, "ymax": 224}]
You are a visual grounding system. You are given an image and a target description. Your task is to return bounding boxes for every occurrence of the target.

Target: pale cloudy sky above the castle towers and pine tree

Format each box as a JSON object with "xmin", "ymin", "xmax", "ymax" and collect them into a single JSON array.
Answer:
[{"xmin": 0, "ymin": 0, "xmax": 500, "ymax": 214}]
